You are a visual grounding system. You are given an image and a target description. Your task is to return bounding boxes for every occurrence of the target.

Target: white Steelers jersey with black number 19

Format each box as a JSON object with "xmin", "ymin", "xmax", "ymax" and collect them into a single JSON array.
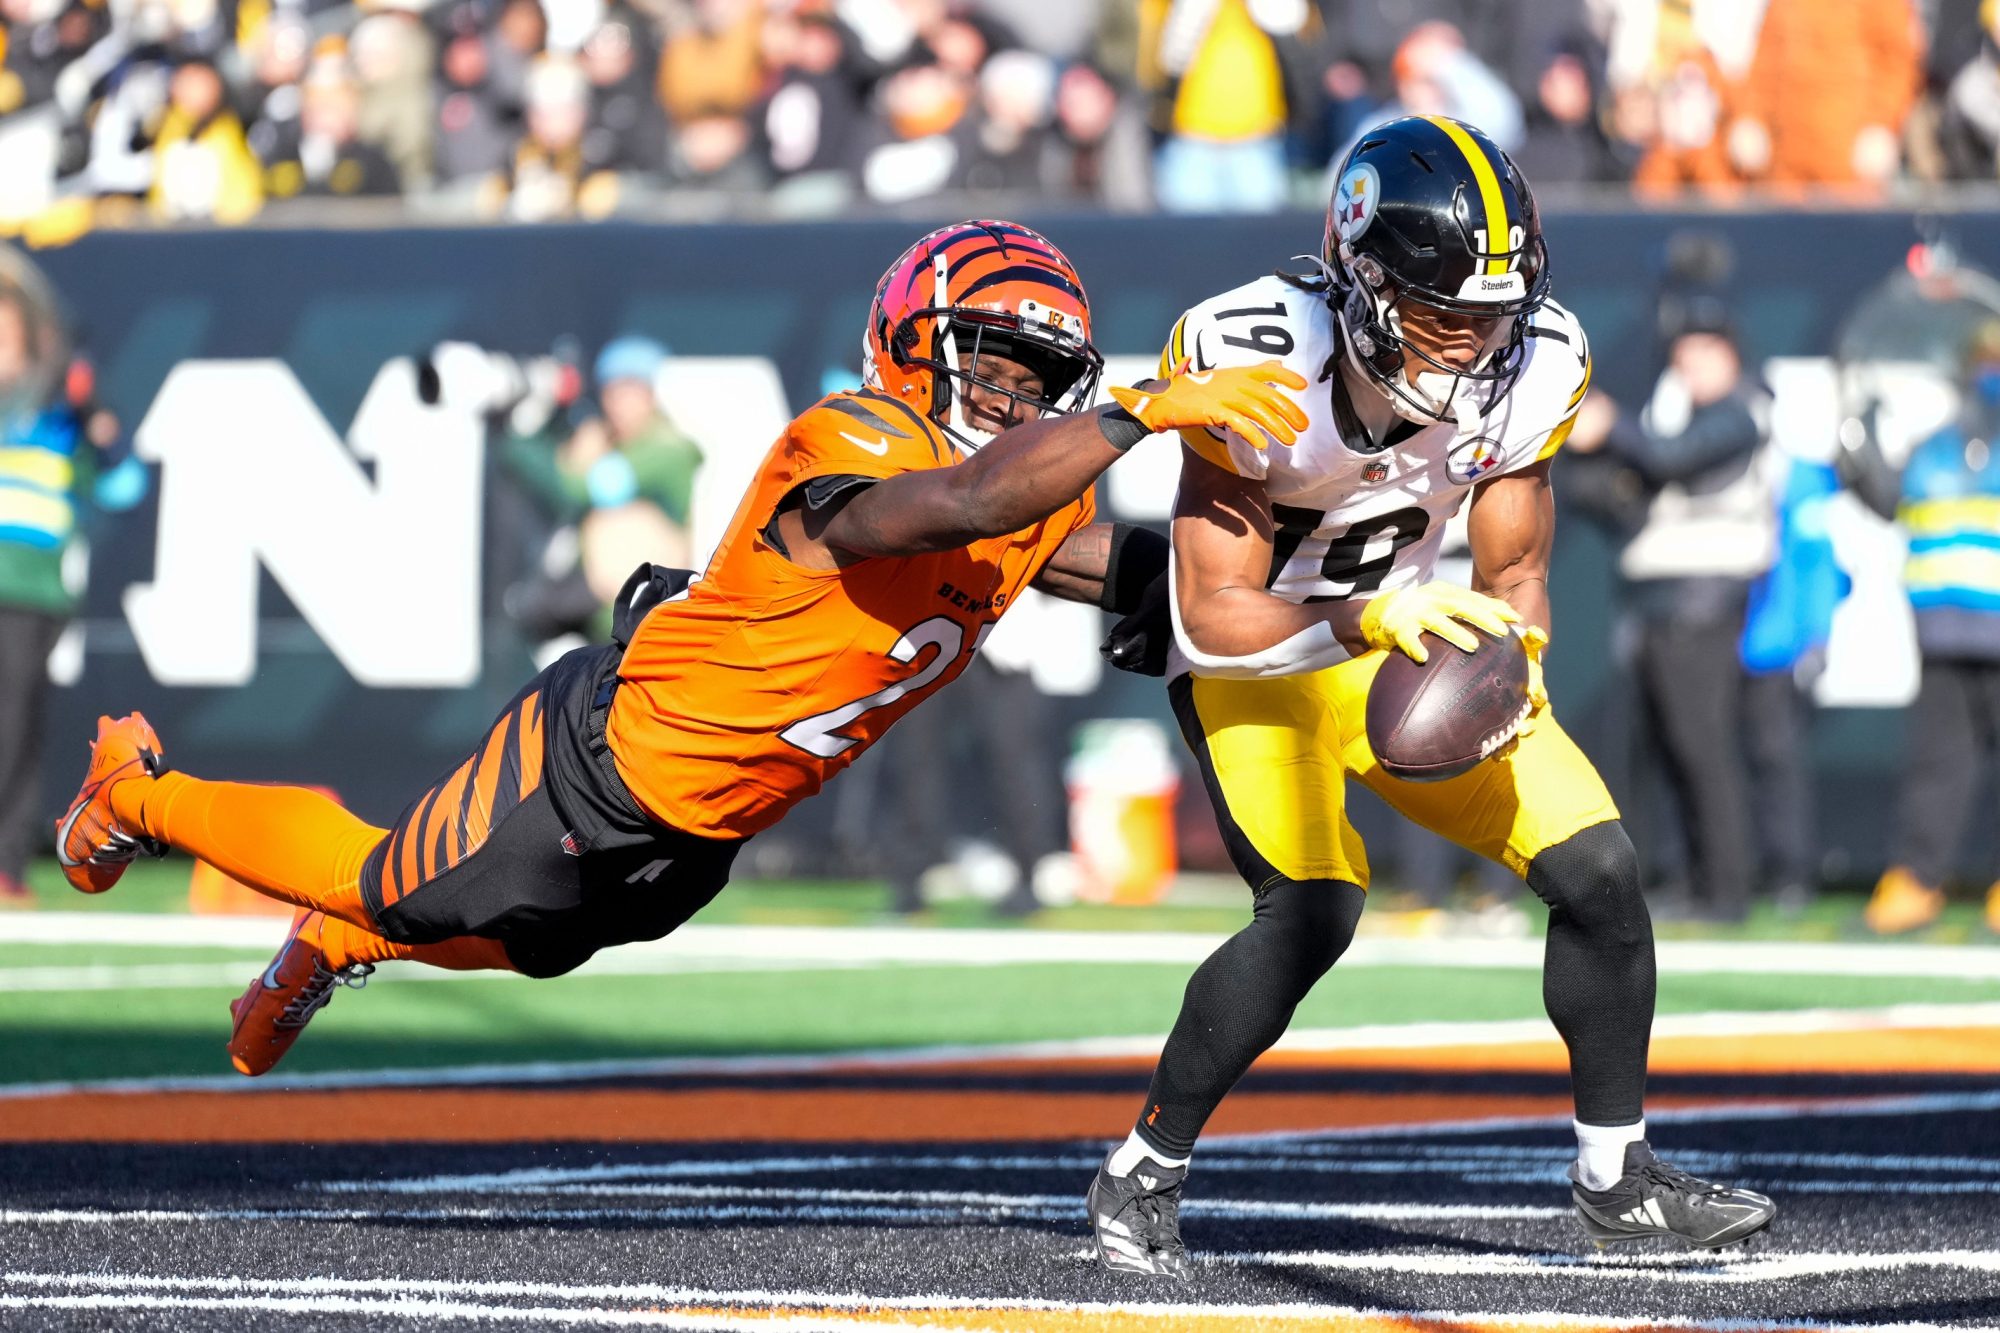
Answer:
[{"xmin": 1166, "ymin": 276, "xmax": 1590, "ymax": 602}]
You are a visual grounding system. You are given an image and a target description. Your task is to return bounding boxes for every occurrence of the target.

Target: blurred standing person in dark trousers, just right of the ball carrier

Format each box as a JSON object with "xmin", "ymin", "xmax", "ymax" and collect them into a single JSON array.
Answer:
[{"xmin": 1570, "ymin": 296, "xmax": 1776, "ymax": 923}]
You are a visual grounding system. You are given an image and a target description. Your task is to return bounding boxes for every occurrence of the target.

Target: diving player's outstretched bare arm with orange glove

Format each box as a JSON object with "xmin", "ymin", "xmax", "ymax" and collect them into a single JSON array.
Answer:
[{"xmin": 822, "ymin": 360, "xmax": 1306, "ymax": 556}]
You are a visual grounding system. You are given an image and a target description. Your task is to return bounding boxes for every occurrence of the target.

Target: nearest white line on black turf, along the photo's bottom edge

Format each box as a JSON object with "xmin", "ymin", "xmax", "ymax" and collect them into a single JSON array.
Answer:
[{"xmin": 0, "ymin": 1251, "xmax": 1952, "ymax": 1333}]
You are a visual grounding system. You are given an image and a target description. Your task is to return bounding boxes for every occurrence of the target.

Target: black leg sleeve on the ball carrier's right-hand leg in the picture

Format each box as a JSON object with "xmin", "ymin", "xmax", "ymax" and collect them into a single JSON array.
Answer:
[{"xmin": 1528, "ymin": 821, "xmax": 1654, "ymax": 1125}]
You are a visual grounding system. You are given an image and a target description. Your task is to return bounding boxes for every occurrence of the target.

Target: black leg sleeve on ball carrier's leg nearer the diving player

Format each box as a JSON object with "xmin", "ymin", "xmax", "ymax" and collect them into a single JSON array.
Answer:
[{"xmin": 1138, "ymin": 879, "xmax": 1366, "ymax": 1157}]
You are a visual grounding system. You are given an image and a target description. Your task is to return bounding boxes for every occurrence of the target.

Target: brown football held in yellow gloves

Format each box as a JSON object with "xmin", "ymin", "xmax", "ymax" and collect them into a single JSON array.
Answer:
[{"xmin": 1368, "ymin": 624, "xmax": 1528, "ymax": 783}]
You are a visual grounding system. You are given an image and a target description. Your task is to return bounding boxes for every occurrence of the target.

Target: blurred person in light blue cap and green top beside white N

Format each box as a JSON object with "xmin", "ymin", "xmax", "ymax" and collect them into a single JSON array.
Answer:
[{"xmin": 500, "ymin": 334, "xmax": 702, "ymax": 642}]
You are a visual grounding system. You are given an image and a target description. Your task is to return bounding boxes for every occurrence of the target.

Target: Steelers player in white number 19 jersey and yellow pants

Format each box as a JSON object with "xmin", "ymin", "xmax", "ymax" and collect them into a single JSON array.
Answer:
[{"xmin": 1088, "ymin": 116, "xmax": 1774, "ymax": 1275}]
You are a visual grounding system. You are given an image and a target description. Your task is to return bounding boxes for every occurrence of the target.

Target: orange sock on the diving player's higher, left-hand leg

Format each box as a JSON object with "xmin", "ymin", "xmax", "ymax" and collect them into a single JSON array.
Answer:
[{"xmin": 110, "ymin": 773, "xmax": 388, "ymax": 928}]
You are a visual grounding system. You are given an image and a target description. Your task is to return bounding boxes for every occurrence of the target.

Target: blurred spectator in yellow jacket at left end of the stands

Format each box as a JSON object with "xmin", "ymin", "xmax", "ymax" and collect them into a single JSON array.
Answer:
[{"xmin": 146, "ymin": 58, "xmax": 264, "ymax": 222}]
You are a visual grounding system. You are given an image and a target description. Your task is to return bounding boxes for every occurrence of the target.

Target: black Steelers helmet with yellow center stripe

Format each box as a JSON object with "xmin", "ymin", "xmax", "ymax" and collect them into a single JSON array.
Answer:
[{"xmin": 1322, "ymin": 116, "xmax": 1548, "ymax": 424}]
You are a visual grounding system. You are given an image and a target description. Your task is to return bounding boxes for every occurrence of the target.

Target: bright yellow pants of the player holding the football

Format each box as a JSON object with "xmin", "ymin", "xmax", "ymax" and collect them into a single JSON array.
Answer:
[{"xmin": 1170, "ymin": 652, "xmax": 1618, "ymax": 889}]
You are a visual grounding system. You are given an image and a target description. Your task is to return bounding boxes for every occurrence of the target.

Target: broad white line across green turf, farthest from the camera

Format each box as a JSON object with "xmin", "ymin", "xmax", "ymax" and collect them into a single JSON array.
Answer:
[{"xmin": 11, "ymin": 913, "xmax": 2000, "ymax": 981}]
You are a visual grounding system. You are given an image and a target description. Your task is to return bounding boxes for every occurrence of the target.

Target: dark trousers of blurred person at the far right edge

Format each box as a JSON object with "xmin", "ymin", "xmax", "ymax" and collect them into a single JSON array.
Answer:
[{"xmin": 1894, "ymin": 656, "xmax": 2000, "ymax": 889}]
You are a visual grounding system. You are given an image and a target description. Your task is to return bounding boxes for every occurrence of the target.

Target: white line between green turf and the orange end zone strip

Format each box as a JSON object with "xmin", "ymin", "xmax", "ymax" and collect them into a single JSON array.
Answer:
[{"xmin": 0, "ymin": 1003, "xmax": 2000, "ymax": 1099}]
